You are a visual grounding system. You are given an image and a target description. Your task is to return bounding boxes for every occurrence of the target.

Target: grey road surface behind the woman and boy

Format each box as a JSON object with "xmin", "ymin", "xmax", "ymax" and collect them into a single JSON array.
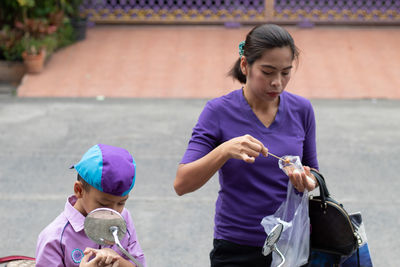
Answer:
[{"xmin": 0, "ymin": 95, "xmax": 400, "ymax": 267}]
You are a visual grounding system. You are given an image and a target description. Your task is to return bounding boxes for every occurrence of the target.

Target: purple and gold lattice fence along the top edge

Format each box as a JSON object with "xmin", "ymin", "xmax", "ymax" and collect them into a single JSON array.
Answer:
[{"xmin": 82, "ymin": 0, "xmax": 400, "ymax": 24}]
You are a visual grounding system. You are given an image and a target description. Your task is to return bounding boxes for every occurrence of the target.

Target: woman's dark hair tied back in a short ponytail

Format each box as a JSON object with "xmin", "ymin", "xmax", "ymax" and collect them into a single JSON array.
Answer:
[{"xmin": 228, "ymin": 24, "xmax": 299, "ymax": 83}]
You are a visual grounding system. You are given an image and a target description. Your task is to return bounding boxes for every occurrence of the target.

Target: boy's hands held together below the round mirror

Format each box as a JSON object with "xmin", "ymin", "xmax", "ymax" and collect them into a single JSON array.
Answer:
[{"xmin": 79, "ymin": 248, "xmax": 121, "ymax": 267}]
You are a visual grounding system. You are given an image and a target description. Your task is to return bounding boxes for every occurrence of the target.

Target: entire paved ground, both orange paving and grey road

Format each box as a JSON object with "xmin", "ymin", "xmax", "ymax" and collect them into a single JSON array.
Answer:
[{"xmin": 0, "ymin": 26, "xmax": 400, "ymax": 267}]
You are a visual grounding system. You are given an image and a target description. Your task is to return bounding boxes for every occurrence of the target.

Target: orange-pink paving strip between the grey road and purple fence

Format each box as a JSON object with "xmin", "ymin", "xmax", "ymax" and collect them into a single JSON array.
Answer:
[{"xmin": 18, "ymin": 25, "xmax": 400, "ymax": 99}]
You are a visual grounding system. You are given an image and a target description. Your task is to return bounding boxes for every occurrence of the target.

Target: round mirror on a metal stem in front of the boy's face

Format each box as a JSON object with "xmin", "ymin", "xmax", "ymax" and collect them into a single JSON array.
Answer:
[{"xmin": 84, "ymin": 208, "xmax": 143, "ymax": 267}]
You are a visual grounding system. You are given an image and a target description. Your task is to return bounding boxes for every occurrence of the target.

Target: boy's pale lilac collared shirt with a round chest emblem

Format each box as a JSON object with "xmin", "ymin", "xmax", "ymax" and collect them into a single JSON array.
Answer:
[{"xmin": 35, "ymin": 196, "xmax": 146, "ymax": 267}]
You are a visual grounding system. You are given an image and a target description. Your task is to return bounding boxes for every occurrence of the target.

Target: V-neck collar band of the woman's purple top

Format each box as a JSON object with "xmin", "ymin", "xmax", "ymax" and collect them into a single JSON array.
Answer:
[{"xmin": 239, "ymin": 87, "xmax": 285, "ymax": 133}]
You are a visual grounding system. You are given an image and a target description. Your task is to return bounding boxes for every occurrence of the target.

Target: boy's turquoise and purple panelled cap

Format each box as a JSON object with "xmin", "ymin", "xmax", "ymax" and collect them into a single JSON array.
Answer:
[{"xmin": 71, "ymin": 144, "xmax": 136, "ymax": 196}]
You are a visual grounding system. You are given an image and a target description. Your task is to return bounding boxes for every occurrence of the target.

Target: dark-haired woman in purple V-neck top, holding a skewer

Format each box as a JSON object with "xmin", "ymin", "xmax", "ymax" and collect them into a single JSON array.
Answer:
[{"xmin": 174, "ymin": 24, "xmax": 318, "ymax": 267}]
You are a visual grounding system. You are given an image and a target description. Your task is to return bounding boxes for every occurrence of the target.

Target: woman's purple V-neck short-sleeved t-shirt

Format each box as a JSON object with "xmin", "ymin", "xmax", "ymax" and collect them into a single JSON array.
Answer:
[{"xmin": 181, "ymin": 89, "xmax": 318, "ymax": 246}]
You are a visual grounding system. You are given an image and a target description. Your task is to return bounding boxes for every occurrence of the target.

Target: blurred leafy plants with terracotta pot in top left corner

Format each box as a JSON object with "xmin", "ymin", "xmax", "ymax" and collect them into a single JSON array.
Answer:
[{"xmin": 0, "ymin": 0, "xmax": 75, "ymax": 80}]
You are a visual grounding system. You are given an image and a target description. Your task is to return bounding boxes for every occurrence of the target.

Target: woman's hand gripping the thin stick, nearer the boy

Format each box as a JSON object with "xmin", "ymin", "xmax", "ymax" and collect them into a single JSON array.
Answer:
[{"xmin": 221, "ymin": 134, "xmax": 268, "ymax": 163}]
